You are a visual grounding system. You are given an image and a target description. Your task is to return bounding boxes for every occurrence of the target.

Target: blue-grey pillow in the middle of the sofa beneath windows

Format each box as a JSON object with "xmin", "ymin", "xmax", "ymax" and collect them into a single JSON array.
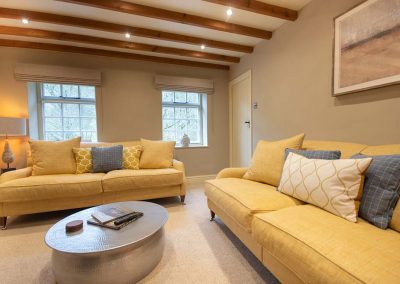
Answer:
[{"xmin": 92, "ymin": 145, "xmax": 123, "ymax": 173}]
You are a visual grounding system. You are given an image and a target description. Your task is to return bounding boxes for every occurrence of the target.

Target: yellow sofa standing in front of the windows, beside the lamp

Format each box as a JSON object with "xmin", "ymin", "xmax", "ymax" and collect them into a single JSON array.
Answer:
[{"xmin": 0, "ymin": 141, "xmax": 186, "ymax": 228}]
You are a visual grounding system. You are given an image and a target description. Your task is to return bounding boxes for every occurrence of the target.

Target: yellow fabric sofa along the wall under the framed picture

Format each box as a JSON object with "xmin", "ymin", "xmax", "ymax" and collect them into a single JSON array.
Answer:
[{"xmin": 205, "ymin": 141, "xmax": 400, "ymax": 283}]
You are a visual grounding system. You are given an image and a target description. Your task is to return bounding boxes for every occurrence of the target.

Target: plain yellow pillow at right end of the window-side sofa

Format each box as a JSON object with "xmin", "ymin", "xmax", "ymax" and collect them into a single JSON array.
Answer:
[{"xmin": 139, "ymin": 139, "xmax": 175, "ymax": 169}]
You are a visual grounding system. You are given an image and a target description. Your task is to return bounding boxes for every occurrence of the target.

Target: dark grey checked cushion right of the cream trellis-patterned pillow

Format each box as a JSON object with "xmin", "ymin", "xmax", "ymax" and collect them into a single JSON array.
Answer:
[{"xmin": 353, "ymin": 154, "xmax": 400, "ymax": 229}]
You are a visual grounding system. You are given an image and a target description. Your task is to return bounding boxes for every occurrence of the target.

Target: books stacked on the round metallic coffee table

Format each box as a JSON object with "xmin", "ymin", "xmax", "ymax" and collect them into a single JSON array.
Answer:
[{"xmin": 87, "ymin": 206, "xmax": 143, "ymax": 230}]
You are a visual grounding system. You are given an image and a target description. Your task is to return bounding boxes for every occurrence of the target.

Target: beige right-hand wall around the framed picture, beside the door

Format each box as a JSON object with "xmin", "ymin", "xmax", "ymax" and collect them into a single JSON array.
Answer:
[{"xmin": 230, "ymin": 0, "xmax": 400, "ymax": 146}]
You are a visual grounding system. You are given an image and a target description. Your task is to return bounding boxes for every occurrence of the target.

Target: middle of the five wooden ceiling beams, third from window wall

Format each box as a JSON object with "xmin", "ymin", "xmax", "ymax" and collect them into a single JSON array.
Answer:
[{"xmin": 0, "ymin": 8, "xmax": 253, "ymax": 53}]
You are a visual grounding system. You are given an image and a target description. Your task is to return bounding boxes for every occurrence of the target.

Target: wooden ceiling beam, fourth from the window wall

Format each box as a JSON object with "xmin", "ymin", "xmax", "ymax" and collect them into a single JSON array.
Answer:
[{"xmin": 56, "ymin": 0, "xmax": 272, "ymax": 39}]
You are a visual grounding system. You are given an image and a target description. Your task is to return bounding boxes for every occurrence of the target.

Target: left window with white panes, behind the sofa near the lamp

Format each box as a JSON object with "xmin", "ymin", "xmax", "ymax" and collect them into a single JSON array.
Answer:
[{"xmin": 39, "ymin": 83, "xmax": 97, "ymax": 142}]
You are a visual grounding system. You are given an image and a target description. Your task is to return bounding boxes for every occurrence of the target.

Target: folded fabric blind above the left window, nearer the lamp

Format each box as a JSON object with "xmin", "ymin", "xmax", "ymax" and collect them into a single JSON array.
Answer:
[{"xmin": 14, "ymin": 63, "xmax": 101, "ymax": 86}]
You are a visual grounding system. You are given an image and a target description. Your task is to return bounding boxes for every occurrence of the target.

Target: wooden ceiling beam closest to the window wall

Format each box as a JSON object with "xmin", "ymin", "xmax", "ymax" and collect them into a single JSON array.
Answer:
[{"xmin": 0, "ymin": 39, "xmax": 229, "ymax": 70}]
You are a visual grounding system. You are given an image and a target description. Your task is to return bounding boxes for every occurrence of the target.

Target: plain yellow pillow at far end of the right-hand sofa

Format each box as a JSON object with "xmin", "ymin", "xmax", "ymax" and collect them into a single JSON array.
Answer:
[{"xmin": 243, "ymin": 133, "xmax": 305, "ymax": 186}]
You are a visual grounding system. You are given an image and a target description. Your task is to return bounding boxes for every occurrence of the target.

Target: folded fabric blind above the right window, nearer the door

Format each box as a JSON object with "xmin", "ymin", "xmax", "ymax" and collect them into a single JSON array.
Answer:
[{"xmin": 155, "ymin": 75, "xmax": 214, "ymax": 94}]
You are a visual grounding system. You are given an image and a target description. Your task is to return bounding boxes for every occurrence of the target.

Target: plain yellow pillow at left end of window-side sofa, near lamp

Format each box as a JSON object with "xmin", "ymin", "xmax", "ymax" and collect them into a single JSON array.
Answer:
[{"xmin": 29, "ymin": 137, "xmax": 81, "ymax": 176}]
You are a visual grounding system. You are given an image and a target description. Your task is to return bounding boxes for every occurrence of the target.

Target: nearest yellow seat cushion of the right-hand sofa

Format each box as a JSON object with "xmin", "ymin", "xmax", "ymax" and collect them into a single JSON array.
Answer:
[{"xmin": 252, "ymin": 205, "xmax": 400, "ymax": 283}]
